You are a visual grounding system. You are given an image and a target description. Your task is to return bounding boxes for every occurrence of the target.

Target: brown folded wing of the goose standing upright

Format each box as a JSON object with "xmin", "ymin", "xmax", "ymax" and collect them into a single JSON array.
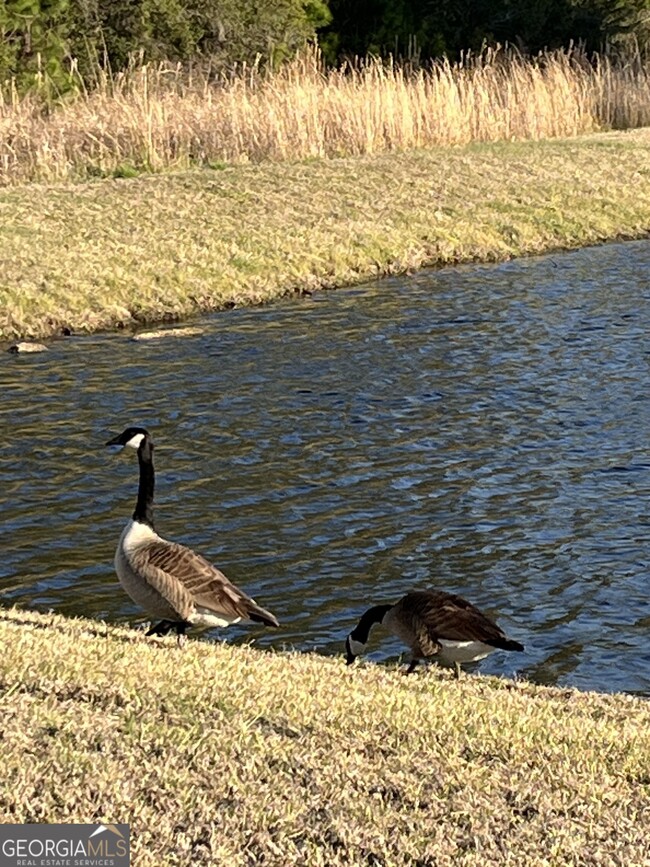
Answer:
[{"xmin": 142, "ymin": 542, "xmax": 257, "ymax": 619}]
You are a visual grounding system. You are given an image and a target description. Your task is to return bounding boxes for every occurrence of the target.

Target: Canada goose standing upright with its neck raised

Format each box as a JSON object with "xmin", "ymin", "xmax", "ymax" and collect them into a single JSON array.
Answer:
[{"xmin": 106, "ymin": 427, "xmax": 278, "ymax": 646}]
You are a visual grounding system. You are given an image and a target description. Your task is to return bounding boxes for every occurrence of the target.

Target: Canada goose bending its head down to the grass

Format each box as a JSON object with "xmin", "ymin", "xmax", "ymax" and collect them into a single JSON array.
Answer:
[{"xmin": 345, "ymin": 590, "xmax": 524, "ymax": 678}]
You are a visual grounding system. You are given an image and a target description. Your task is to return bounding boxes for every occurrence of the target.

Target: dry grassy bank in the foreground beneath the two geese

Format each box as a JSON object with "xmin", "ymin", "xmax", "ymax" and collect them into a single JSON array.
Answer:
[{"xmin": 0, "ymin": 610, "xmax": 650, "ymax": 867}]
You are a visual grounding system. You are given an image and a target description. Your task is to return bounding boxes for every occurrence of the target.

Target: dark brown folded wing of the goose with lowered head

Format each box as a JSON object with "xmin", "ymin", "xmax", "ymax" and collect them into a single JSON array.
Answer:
[{"xmin": 394, "ymin": 590, "xmax": 507, "ymax": 644}]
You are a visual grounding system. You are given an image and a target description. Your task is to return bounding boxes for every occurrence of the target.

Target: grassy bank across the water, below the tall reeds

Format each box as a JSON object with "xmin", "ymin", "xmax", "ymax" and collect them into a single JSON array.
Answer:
[{"xmin": 0, "ymin": 130, "xmax": 650, "ymax": 339}]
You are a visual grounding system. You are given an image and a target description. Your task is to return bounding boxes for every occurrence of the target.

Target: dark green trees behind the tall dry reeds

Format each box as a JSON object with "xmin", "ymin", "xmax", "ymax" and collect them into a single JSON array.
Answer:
[{"xmin": 0, "ymin": 0, "xmax": 650, "ymax": 87}]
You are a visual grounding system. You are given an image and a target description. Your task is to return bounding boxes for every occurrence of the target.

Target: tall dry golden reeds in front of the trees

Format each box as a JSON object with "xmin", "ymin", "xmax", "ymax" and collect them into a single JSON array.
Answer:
[{"xmin": 0, "ymin": 50, "xmax": 650, "ymax": 185}]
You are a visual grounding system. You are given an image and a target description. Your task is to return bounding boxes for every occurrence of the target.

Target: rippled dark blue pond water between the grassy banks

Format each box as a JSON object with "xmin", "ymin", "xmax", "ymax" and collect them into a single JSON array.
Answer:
[{"xmin": 0, "ymin": 242, "xmax": 650, "ymax": 694}]
